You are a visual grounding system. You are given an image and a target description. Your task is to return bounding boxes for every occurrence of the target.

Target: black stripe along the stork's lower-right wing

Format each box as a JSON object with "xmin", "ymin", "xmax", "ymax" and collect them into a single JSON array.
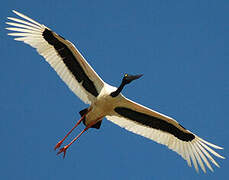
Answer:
[{"xmin": 114, "ymin": 107, "xmax": 195, "ymax": 142}]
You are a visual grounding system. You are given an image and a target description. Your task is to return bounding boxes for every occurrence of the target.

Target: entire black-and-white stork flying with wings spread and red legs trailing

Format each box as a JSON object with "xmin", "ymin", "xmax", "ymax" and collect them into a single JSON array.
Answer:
[{"xmin": 6, "ymin": 10, "xmax": 224, "ymax": 172}]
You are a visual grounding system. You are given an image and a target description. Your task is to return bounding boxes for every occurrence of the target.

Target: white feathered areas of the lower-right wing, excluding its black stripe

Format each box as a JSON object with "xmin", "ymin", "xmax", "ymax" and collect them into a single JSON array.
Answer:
[{"xmin": 106, "ymin": 98, "xmax": 224, "ymax": 173}]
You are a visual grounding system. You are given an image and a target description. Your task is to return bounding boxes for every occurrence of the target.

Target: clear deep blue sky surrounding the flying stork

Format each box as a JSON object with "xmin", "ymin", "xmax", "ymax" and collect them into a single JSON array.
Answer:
[{"xmin": 0, "ymin": 0, "xmax": 229, "ymax": 180}]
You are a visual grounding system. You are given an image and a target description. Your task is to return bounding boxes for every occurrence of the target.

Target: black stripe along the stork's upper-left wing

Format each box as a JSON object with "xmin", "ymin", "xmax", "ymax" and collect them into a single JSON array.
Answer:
[{"xmin": 43, "ymin": 29, "xmax": 99, "ymax": 97}]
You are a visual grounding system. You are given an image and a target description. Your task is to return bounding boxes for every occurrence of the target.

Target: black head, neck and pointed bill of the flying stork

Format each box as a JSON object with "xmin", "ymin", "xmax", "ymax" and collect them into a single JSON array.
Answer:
[{"xmin": 110, "ymin": 74, "xmax": 143, "ymax": 97}]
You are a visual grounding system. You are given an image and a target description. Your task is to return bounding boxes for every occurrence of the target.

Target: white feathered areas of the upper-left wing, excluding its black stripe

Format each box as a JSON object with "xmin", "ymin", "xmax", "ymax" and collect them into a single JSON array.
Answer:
[{"xmin": 6, "ymin": 11, "xmax": 104, "ymax": 104}]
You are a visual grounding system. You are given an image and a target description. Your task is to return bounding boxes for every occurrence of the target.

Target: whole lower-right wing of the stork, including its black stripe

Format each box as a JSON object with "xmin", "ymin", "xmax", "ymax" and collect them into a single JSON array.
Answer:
[{"xmin": 107, "ymin": 98, "xmax": 224, "ymax": 172}]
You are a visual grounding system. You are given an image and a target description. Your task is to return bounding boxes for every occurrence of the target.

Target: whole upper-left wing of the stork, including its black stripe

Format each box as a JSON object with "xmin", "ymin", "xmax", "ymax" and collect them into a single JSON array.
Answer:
[{"xmin": 6, "ymin": 11, "xmax": 104, "ymax": 104}]
